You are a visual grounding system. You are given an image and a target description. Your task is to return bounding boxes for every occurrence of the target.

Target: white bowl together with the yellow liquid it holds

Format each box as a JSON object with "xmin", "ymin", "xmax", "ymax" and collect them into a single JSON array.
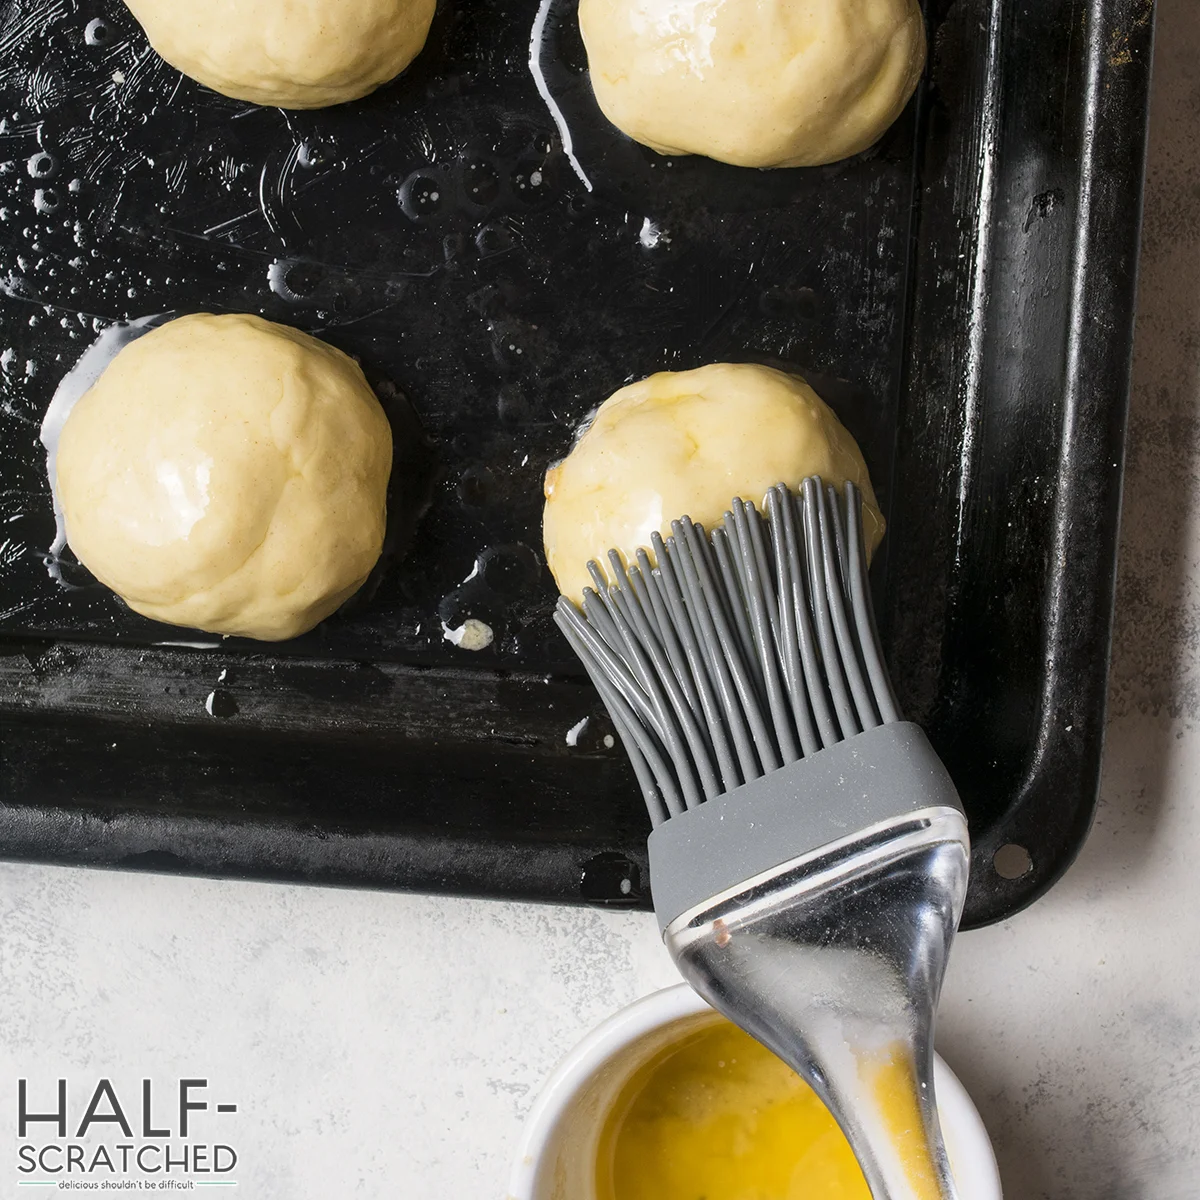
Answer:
[{"xmin": 509, "ymin": 984, "xmax": 1001, "ymax": 1200}]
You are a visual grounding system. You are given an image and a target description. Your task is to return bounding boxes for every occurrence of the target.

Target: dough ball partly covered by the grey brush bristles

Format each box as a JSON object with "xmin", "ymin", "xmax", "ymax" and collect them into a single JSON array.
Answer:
[{"xmin": 542, "ymin": 362, "xmax": 883, "ymax": 604}]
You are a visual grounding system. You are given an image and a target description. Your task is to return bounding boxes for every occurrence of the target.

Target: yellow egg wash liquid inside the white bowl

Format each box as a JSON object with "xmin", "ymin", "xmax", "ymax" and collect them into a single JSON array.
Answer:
[{"xmin": 596, "ymin": 1021, "xmax": 873, "ymax": 1200}]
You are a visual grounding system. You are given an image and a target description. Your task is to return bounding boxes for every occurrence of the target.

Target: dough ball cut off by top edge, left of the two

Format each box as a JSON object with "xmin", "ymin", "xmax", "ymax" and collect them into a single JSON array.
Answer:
[{"xmin": 126, "ymin": 0, "xmax": 436, "ymax": 108}]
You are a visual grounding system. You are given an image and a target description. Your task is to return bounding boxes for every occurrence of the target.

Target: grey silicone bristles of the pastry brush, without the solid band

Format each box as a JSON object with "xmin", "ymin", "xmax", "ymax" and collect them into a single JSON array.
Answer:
[{"xmin": 554, "ymin": 476, "xmax": 900, "ymax": 826}]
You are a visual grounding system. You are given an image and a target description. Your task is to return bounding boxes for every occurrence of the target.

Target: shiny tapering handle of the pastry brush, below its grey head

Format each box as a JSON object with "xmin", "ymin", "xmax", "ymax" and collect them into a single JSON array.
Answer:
[{"xmin": 664, "ymin": 808, "xmax": 968, "ymax": 1200}]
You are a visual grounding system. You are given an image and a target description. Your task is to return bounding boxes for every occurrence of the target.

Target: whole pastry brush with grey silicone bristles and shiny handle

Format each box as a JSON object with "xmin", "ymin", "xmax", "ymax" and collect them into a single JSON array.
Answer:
[{"xmin": 554, "ymin": 478, "xmax": 968, "ymax": 1200}]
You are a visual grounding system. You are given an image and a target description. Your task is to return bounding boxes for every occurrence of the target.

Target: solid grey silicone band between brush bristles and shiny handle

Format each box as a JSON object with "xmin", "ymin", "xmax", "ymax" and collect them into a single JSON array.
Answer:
[{"xmin": 649, "ymin": 721, "xmax": 962, "ymax": 931}]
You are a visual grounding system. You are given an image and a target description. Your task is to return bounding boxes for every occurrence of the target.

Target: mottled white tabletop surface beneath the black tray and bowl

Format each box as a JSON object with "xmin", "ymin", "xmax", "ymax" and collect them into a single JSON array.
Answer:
[{"xmin": 0, "ymin": 0, "xmax": 1200, "ymax": 1200}]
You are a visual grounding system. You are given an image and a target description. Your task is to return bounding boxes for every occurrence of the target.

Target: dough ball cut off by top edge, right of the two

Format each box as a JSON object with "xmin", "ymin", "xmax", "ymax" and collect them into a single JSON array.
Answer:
[{"xmin": 580, "ymin": 0, "xmax": 925, "ymax": 167}]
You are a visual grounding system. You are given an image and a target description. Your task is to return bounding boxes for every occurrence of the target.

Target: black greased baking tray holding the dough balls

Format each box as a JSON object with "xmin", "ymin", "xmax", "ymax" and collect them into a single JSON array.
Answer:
[{"xmin": 0, "ymin": 0, "xmax": 1153, "ymax": 924}]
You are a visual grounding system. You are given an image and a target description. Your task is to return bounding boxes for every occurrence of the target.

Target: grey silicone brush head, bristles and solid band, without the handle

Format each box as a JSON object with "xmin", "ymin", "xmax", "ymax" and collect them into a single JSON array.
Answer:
[{"xmin": 556, "ymin": 478, "xmax": 961, "ymax": 931}]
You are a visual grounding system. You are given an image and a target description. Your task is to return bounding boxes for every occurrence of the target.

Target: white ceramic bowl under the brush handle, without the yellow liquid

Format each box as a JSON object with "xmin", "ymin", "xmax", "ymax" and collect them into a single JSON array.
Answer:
[{"xmin": 509, "ymin": 984, "xmax": 1002, "ymax": 1200}]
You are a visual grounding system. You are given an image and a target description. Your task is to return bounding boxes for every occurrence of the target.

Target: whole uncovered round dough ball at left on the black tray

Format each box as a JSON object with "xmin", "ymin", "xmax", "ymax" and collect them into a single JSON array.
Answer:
[{"xmin": 55, "ymin": 313, "xmax": 391, "ymax": 641}]
